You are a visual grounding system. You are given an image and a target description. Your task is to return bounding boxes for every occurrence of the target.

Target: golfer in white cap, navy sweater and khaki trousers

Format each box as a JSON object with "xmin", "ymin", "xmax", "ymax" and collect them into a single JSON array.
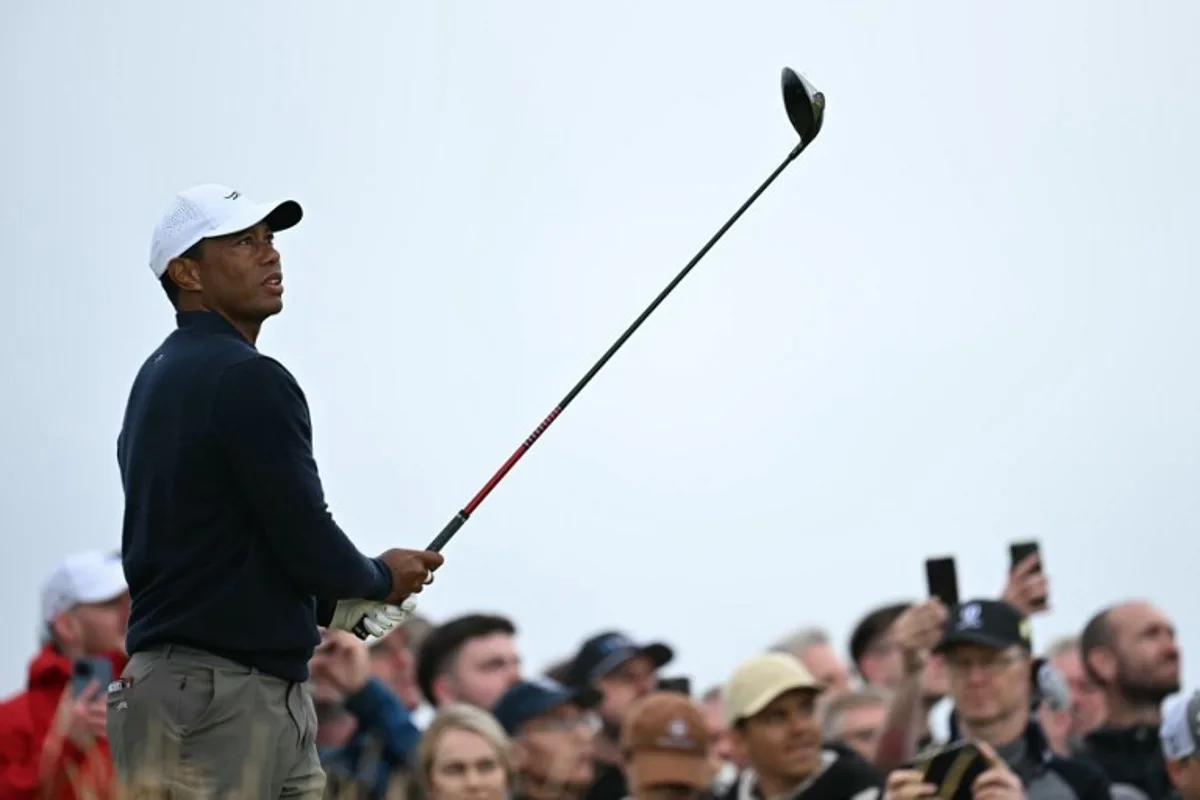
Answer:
[{"xmin": 107, "ymin": 185, "xmax": 442, "ymax": 799}]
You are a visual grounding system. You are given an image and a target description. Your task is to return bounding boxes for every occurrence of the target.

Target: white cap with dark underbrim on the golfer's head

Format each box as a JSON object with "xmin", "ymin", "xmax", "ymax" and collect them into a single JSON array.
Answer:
[{"xmin": 150, "ymin": 184, "xmax": 304, "ymax": 278}]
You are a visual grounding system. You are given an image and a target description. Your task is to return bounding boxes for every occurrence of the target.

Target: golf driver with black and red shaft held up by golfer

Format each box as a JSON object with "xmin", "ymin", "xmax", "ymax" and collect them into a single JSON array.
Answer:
[{"xmin": 355, "ymin": 67, "xmax": 826, "ymax": 638}]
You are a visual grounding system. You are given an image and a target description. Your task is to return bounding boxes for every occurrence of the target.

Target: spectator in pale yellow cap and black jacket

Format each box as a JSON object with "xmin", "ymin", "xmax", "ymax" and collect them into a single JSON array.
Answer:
[{"xmin": 722, "ymin": 652, "xmax": 883, "ymax": 800}]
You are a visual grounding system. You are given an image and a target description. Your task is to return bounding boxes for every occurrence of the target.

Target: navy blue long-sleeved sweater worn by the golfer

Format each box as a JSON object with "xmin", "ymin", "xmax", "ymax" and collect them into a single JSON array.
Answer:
[{"xmin": 116, "ymin": 312, "xmax": 391, "ymax": 681}]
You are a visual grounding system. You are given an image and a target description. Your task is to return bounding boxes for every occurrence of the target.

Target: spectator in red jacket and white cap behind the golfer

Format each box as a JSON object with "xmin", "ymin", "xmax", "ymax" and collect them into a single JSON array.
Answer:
[{"xmin": 0, "ymin": 553, "xmax": 128, "ymax": 800}]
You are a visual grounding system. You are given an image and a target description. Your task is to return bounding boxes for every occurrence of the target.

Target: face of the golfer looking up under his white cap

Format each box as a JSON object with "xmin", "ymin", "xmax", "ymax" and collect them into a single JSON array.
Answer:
[{"xmin": 199, "ymin": 223, "xmax": 283, "ymax": 321}]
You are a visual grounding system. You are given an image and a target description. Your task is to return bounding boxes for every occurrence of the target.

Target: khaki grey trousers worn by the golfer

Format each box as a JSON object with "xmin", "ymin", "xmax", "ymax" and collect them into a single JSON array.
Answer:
[{"xmin": 108, "ymin": 645, "xmax": 325, "ymax": 800}]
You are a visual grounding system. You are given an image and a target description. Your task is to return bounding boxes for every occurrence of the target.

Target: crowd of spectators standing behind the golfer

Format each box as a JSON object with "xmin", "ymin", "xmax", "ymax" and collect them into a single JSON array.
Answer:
[{"xmin": 0, "ymin": 553, "xmax": 1185, "ymax": 800}]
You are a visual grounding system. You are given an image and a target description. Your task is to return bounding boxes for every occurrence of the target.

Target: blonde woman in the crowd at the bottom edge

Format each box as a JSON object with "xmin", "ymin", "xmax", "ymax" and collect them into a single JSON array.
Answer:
[{"xmin": 416, "ymin": 704, "xmax": 515, "ymax": 800}]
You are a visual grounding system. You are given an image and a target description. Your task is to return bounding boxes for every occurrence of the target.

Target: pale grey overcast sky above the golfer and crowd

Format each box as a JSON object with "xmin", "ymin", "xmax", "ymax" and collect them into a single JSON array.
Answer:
[{"xmin": 0, "ymin": 0, "xmax": 1200, "ymax": 688}]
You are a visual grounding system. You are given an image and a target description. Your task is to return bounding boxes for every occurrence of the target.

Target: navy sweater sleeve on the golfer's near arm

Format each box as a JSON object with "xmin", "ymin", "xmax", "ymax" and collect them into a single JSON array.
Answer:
[{"xmin": 212, "ymin": 357, "xmax": 391, "ymax": 606}]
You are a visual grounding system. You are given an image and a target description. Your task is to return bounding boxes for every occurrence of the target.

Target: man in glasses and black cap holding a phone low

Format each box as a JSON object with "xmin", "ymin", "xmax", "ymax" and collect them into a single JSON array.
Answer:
[{"xmin": 884, "ymin": 600, "xmax": 1111, "ymax": 800}]
